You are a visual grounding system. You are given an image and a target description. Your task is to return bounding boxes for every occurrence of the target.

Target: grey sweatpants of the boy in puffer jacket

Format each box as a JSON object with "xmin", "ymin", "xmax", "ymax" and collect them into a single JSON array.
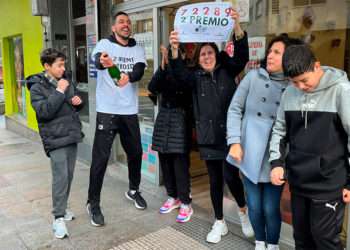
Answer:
[{"xmin": 50, "ymin": 144, "xmax": 77, "ymax": 216}]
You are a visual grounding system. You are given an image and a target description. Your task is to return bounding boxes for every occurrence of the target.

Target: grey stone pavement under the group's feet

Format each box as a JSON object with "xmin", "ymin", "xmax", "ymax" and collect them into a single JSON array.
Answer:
[{"xmin": 0, "ymin": 116, "xmax": 264, "ymax": 250}]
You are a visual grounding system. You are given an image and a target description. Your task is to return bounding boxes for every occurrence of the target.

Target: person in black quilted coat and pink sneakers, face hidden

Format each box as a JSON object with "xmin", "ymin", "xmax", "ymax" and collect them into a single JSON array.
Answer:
[{"xmin": 148, "ymin": 47, "xmax": 193, "ymax": 222}]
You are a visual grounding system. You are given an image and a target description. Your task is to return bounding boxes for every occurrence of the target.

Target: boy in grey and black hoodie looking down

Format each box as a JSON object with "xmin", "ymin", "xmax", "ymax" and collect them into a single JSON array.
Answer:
[{"xmin": 270, "ymin": 45, "xmax": 350, "ymax": 250}]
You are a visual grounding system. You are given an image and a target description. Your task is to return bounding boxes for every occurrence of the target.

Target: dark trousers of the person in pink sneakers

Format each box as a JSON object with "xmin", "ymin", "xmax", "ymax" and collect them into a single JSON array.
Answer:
[{"xmin": 158, "ymin": 153, "xmax": 191, "ymax": 204}]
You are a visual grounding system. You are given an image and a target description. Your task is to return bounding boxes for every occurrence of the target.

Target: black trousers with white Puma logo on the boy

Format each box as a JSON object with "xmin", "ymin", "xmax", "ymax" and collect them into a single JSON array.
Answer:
[{"xmin": 291, "ymin": 193, "xmax": 345, "ymax": 250}]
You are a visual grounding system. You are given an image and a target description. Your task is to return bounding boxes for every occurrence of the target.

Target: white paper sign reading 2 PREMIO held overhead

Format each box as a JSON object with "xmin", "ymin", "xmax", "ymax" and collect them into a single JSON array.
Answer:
[{"xmin": 174, "ymin": 2, "xmax": 234, "ymax": 43}]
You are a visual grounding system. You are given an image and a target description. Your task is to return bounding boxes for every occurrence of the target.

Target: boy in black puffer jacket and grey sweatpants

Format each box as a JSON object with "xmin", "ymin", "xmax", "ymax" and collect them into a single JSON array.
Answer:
[{"xmin": 27, "ymin": 49, "xmax": 83, "ymax": 239}]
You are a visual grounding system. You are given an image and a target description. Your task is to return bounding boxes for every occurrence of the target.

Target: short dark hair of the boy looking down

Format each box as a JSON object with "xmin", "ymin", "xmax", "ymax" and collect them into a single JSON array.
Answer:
[{"xmin": 282, "ymin": 44, "xmax": 317, "ymax": 77}]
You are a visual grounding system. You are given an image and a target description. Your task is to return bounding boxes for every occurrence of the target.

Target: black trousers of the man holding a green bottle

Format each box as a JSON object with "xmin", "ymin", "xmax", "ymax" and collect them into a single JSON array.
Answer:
[{"xmin": 88, "ymin": 113, "xmax": 142, "ymax": 205}]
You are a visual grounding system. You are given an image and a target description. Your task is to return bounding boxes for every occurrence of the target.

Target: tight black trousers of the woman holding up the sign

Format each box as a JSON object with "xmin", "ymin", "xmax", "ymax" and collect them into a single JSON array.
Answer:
[{"xmin": 205, "ymin": 160, "xmax": 246, "ymax": 220}]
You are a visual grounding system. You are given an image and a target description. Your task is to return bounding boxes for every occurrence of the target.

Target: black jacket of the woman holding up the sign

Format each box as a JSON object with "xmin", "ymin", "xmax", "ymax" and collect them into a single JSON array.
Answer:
[{"xmin": 170, "ymin": 34, "xmax": 249, "ymax": 160}]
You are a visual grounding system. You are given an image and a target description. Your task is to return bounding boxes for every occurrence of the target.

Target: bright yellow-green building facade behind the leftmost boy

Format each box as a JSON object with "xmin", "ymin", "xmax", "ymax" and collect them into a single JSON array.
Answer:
[{"xmin": 0, "ymin": 0, "xmax": 44, "ymax": 135}]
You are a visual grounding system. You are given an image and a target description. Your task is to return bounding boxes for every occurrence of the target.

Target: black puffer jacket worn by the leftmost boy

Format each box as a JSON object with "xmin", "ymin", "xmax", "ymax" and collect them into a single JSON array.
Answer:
[{"xmin": 27, "ymin": 73, "xmax": 84, "ymax": 156}]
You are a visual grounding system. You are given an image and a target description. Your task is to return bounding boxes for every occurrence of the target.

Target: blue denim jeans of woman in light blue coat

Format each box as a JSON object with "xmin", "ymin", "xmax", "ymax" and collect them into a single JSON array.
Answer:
[{"xmin": 243, "ymin": 176, "xmax": 283, "ymax": 244}]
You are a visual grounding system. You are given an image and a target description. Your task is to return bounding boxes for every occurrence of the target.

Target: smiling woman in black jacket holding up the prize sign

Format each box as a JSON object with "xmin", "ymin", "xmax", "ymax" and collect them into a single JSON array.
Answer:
[{"xmin": 170, "ymin": 10, "xmax": 254, "ymax": 243}]
